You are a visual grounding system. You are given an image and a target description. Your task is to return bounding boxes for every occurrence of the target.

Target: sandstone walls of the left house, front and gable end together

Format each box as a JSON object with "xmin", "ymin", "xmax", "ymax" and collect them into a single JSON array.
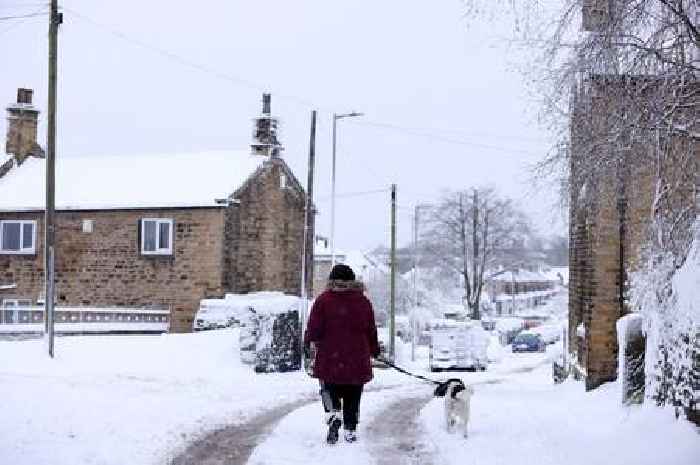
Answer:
[{"xmin": 0, "ymin": 159, "xmax": 306, "ymax": 332}]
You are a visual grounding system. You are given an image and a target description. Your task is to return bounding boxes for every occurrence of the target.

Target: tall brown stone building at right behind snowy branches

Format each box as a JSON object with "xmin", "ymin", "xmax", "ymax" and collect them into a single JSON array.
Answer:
[{"xmin": 569, "ymin": 75, "xmax": 700, "ymax": 389}]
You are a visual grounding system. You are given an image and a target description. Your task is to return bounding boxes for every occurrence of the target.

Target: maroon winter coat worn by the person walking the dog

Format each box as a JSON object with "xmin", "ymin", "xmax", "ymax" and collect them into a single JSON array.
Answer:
[{"xmin": 304, "ymin": 281, "xmax": 379, "ymax": 384}]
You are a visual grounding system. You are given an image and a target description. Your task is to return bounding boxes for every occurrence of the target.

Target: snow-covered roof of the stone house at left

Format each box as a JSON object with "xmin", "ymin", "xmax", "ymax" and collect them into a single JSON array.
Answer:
[{"xmin": 0, "ymin": 151, "xmax": 267, "ymax": 211}]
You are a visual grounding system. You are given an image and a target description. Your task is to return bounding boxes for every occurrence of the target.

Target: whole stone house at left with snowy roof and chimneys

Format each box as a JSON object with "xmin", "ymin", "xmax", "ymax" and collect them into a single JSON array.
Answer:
[{"xmin": 0, "ymin": 89, "xmax": 305, "ymax": 332}]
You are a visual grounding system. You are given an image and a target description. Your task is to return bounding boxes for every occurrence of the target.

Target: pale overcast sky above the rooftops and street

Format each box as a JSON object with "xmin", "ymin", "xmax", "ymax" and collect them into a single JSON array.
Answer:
[{"xmin": 0, "ymin": 0, "xmax": 563, "ymax": 249}]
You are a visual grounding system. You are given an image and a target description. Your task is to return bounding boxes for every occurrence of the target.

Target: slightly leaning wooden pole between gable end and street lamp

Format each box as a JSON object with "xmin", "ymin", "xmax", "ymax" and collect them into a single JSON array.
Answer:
[{"xmin": 299, "ymin": 110, "xmax": 316, "ymax": 370}]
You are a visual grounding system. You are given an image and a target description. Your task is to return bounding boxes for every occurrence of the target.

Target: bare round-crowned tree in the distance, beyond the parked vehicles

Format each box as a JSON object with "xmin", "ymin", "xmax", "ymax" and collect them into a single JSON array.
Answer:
[{"xmin": 421, "ymin": 188, "xmax": 530, "ymax": 319}]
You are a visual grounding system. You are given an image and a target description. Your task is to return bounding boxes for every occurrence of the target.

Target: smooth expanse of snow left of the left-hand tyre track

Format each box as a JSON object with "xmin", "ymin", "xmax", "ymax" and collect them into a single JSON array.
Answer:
[{"xmin": 0, "ymin": 329, "xmax": 406, "ymax": 465}]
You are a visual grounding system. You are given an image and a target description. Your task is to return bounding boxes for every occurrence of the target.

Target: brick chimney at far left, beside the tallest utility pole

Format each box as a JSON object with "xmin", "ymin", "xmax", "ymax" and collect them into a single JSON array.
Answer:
[{"xmin": 5, "ymin": 88, "xmax": 44, "ymax": 165}]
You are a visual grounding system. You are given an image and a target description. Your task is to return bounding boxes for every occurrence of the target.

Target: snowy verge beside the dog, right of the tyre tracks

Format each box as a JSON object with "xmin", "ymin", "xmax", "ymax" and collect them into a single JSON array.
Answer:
[{"xmin": 421, "ymin": 367, "xmax": 700, "ymax": 465}]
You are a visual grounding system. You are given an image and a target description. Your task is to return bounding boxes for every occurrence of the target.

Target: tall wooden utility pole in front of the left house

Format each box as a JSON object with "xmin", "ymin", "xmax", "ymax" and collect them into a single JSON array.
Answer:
[{"xmin": 44, "ymin": 0, "xmax": 63, "ymax": 358}]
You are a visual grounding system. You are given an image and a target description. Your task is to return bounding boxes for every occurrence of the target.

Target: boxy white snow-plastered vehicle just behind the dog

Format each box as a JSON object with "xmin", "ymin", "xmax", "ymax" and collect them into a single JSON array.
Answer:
[{"xmin": 429, "ymin": 320, "xmax": 489, "ymax": 371}]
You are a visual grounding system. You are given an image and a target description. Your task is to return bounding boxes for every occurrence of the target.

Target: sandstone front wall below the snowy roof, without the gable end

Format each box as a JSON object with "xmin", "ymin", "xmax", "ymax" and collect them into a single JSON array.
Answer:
[{"xmin": 0, "ymin": 208, "xmax": 224, "ymax": 332}]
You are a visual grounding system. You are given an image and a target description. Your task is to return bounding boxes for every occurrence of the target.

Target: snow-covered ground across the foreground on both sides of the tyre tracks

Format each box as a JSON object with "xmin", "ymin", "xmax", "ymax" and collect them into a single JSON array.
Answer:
[{"xmin": 0, "ymin": 292, "xmax": 700, "ymax": 465}]
